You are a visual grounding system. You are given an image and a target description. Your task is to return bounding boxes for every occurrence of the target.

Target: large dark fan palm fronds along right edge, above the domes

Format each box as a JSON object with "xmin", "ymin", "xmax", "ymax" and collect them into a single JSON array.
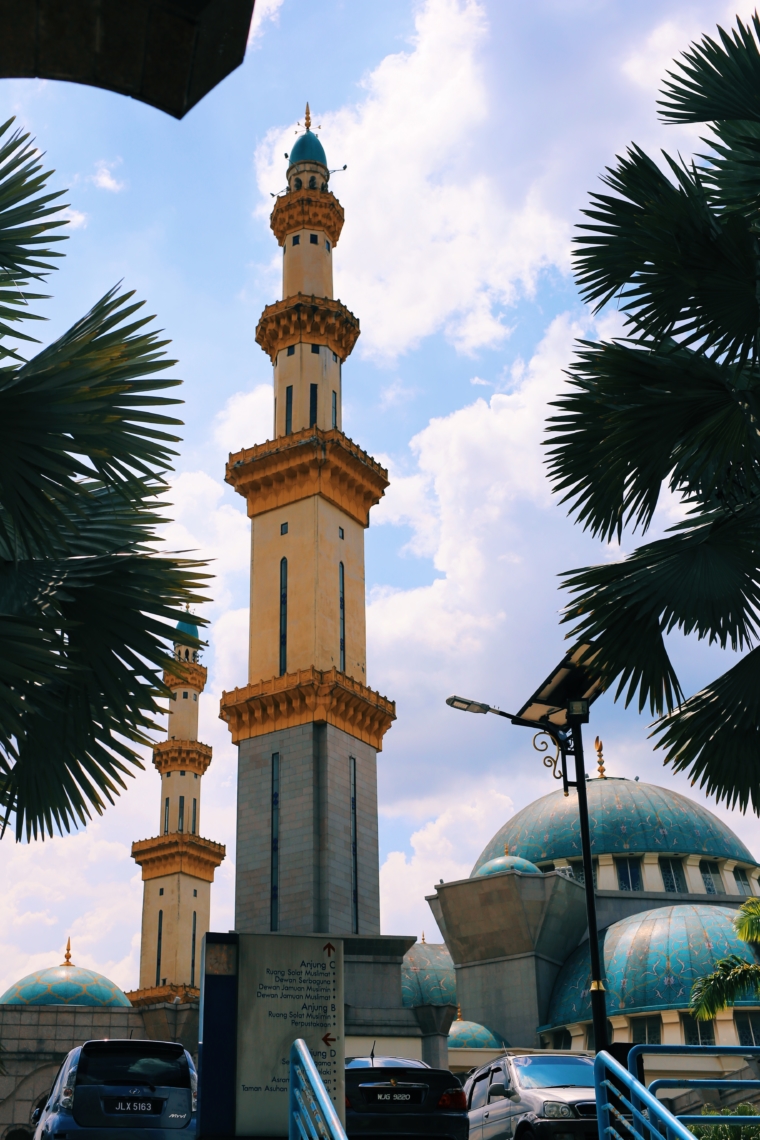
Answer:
[{"xmin": 548, "ymin": 15, "xmax": 760, "ymax": 813}]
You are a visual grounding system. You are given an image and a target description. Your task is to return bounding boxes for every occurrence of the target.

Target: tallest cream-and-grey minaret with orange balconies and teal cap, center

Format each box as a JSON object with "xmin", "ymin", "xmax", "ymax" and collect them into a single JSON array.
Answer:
[{"xmin": 221, "ymin": 105, "xmax": 395, "ymax": 935}]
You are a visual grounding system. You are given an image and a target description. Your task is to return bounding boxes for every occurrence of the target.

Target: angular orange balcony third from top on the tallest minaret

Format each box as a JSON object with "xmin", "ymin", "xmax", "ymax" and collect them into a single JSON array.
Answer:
[{"xmin": 224, "ymin": 428, "xmax": 389, "ymax": 527}]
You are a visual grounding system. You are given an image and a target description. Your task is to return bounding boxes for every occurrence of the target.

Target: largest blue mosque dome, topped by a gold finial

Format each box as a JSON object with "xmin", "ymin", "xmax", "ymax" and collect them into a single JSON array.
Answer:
[{"xmin": 473, "ymin": 776, "xmax": 757, "ymax": 874}]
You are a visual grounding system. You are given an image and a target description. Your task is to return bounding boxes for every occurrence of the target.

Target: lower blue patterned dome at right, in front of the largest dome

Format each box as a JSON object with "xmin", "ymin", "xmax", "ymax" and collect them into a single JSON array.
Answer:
[{"xmin": 542, "ymin": 903, "xmax": 758, "ymax": 1028}]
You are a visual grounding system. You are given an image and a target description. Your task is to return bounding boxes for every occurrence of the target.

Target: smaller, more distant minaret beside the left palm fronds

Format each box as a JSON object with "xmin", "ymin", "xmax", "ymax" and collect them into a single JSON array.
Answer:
[{"xmin": 128, "ymin": 614, "xmax": 224, "ymax": 1004}]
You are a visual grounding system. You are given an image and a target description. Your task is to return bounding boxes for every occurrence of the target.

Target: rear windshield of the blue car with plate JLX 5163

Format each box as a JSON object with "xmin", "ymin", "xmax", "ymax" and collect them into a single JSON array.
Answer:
[{"xmin": 76, "ymin": 1042, "xmax": 190, "ymax": 1089}]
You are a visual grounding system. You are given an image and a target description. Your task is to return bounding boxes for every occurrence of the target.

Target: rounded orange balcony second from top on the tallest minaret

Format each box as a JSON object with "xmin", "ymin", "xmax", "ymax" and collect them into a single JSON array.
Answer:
[{"xmin": 256, "ymin": 293, "xmax": 359, "ymax": 364}]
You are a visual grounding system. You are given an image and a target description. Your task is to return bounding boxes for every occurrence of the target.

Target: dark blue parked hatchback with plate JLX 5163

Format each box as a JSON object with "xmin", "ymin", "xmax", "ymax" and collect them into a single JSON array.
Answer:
[{"xmin": 32, "ymin": 1040, "xmax": 198, "ymax": 1140}]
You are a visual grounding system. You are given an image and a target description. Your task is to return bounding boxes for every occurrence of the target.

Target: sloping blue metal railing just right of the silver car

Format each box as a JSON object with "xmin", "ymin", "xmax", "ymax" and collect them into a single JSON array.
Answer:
[{"xmin": 594, "ymin": 1049, "xmax": 697, "ymax": 1140}]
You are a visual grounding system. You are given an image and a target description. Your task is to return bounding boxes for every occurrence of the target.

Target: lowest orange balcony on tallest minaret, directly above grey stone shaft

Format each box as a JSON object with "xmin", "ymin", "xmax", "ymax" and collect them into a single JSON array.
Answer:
[{"xmin": 219, "ymin": 666, "xmax": 395, "ymax": 752}]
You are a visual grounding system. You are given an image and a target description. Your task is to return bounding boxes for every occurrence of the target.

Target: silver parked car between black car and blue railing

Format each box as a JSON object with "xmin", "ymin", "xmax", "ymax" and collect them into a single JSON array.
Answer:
[{"xmin": 465, "ymin": 1052, "xmax": 597, "ymax": 1140}]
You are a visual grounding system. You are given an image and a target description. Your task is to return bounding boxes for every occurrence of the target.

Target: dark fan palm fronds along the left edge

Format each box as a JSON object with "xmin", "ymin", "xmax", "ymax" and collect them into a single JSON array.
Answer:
[{"xmin": 0, "ymin": 120, "xmax": 207, "ymax": 839}]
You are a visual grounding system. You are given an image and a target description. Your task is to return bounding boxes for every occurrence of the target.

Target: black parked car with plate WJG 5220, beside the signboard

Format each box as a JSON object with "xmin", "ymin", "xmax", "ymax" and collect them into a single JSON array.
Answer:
[{"xmin": 345, "ymin": 1057, "xmax": 469, "ymax": 1140}]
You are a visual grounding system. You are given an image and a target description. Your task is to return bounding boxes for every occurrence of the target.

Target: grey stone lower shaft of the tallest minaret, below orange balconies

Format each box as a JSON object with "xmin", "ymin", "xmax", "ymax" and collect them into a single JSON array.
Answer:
[{"xmin": 235, "ymin": 724, "xmax": 379, "ymax": 935}]
